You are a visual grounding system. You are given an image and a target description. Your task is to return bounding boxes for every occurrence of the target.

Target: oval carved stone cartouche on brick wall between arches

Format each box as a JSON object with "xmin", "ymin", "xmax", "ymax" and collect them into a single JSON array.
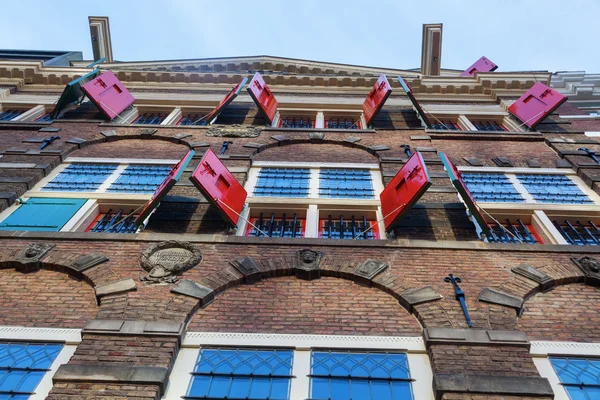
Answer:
[{"xmin": 140, "ymin": 240, "xmax": 202, "ymax": 283}]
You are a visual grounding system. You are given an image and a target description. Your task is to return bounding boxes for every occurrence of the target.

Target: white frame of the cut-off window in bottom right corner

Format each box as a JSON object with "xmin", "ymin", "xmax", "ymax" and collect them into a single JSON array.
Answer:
[{"xmin": 529, "ymin": 340, "xmax": 600, "ymax": 400}]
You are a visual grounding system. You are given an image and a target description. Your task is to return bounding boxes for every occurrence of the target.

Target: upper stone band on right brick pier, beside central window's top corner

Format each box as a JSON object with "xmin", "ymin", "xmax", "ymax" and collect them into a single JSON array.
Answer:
[{"xmin": 423, "ymin": 328, "xmax": 531, "ymax": 349}]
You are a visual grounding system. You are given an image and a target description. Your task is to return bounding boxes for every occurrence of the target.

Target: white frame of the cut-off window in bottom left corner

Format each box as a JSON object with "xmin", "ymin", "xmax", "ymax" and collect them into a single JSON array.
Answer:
[{"xmin": 0, "ymin": 326, "xmax": 81, "ymax": 400}]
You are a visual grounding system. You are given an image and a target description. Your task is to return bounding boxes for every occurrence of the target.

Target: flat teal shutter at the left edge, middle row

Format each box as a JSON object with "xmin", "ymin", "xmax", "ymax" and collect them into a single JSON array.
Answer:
[{"xmin": 0, "ymin": 198, "xmax": 87, "ymax": 232}]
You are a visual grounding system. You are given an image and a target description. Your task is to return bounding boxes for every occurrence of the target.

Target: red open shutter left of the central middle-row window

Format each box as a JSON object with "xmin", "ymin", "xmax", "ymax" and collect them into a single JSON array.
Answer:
[{"xmin": 190, "ymin": 149, "xmax": 248, "ymax": 226}]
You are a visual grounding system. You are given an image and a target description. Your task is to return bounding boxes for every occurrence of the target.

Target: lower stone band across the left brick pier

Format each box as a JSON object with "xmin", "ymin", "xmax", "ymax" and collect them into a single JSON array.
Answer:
[{"xmin": 52, "ymin": 364, "xmax": 169, "ymax": 395}]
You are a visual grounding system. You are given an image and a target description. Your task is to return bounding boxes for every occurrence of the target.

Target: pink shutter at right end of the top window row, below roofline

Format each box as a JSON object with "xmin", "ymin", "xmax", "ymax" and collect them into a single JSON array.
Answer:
[{"xmin": 508, "ymin": 82, "xmax": 567, "ymax": 128}]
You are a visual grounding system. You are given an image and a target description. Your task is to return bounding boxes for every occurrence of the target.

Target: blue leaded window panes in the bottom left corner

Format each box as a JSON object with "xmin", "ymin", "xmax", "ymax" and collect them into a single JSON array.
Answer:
[{"xmin": 0, "ymin": 343, "xmax": 63, "ymax": 400}]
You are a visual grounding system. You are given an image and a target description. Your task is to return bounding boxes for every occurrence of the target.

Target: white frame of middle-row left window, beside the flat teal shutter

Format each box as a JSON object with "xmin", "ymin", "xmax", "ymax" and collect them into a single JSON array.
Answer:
[{"xmin": 0, "ymin": 157, "xmax": 180, "ymax": 232}]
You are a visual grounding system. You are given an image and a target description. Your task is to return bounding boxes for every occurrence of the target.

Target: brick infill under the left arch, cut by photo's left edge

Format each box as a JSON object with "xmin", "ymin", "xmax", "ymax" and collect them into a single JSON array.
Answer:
[{"xmin": 0, "ymin": 269, "xmax": 98, "ymax": 328}]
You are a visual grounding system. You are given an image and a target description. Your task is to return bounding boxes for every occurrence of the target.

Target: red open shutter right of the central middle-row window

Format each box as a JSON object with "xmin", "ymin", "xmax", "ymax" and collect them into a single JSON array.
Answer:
[{"xmin": 379, "ymin": 151, "xmax": 431, "ymax": 231}]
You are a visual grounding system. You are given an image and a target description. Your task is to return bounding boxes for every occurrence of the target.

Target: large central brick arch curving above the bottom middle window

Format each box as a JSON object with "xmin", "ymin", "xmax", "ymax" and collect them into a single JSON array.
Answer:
[{"xmin": 172, "ymin": 255, "xmax": 450, "ymax": 327}]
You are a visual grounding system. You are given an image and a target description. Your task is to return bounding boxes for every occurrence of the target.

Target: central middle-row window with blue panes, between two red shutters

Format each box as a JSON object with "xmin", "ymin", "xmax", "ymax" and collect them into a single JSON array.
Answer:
[{"xmin": 243, "ymin": 162, "xmax": 384, "ymax": 240}]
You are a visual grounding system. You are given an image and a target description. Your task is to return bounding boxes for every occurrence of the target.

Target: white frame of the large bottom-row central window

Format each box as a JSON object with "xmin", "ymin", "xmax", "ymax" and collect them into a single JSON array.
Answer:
[{"xmin": 162, "ymin": 332, "xmax": 434, "ymax": 400}]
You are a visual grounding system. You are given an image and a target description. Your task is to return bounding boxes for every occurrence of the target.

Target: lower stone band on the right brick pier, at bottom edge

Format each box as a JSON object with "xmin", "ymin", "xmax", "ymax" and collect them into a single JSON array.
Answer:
[{"xmin": 433, "ymin": 374, "xmax": 554, "ymax": 400}]
